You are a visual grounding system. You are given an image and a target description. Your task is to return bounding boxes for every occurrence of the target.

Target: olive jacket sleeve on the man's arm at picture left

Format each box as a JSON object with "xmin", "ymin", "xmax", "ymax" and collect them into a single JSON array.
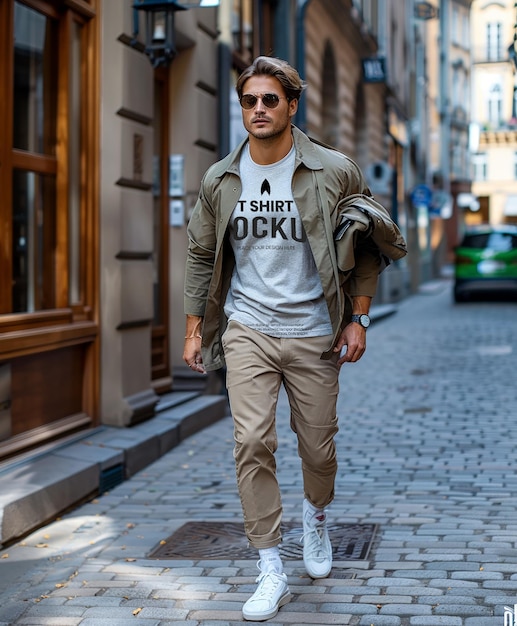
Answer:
[{"xmin": 184, "ymin": 177, "xmax": 216, "ymax": 317}]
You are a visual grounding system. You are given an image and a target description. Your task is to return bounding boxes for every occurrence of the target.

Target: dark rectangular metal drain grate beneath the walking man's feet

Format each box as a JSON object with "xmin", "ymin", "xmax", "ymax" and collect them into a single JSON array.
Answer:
[{"xmin": 149, "ymin": 522, "xmax": 377, "ymax": 561}]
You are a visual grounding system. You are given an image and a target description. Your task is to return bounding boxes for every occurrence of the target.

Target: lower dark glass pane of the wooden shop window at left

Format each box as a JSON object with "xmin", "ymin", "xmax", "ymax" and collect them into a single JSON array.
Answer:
[{"xmin": 12, "ymin": 170, "xmax": 56, "ymax": 313}]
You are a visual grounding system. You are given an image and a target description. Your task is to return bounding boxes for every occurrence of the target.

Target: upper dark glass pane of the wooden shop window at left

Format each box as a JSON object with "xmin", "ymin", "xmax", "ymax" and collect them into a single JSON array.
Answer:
[{"xmin": 13, "ymin": 2, "xmax": 58, "ymax": 155}]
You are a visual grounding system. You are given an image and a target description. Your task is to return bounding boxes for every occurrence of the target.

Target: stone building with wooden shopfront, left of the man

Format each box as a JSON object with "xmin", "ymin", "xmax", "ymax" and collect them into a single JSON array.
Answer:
[{"xmin": 0, "ymin": 0, "xmax": 218, "ymax": 461}]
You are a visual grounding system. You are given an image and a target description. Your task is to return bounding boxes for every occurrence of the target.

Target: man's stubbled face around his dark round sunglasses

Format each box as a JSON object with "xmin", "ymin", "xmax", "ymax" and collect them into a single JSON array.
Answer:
[{"xmin": 242, "ymin": 76, "xmax": 298, "ymax": 139}]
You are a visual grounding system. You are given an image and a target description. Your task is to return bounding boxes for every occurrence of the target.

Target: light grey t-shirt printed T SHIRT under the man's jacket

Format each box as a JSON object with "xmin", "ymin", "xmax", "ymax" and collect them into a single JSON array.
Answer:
[{"xmin": 225, "ymin": 147, "xmax": 332, "ymax": 337}]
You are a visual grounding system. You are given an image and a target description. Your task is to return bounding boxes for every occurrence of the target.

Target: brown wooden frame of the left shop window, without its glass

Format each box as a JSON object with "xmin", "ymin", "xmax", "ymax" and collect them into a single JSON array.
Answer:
[{"xmin": 0, "ymin": 0, "xmax": 99, "ymax": 336}]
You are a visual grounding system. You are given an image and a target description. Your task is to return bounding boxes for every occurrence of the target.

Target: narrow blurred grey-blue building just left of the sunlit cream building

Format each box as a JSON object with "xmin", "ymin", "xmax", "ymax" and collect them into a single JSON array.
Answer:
[{"xmin": 425, "ymin": 0, "xmax": 472, "ymax": 266}]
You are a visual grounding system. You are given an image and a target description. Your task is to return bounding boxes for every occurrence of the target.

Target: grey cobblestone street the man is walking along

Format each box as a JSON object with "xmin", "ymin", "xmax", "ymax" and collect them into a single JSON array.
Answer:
[{"xmin": 0, "ymin": 279, "xmax": 517, "ymax": 626}]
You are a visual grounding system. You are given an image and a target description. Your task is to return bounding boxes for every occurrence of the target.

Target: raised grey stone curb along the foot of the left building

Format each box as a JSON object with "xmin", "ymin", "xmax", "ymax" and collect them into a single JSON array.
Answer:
[{"xmin": 0, "ymin": 392, "xmax": 229, "ymax": 548}]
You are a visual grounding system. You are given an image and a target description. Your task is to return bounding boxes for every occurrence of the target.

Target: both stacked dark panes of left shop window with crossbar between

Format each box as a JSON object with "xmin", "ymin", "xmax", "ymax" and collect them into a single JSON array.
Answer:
[{"xmin": 10, "ymin": 2, "xmax": 58, "ymax": 313}]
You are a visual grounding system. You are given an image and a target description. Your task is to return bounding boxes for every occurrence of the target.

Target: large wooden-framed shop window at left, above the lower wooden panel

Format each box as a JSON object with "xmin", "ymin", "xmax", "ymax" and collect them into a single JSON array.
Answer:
[{"xmin": 0, "ymin": 0, "xmax": 94, "ymax": 320}]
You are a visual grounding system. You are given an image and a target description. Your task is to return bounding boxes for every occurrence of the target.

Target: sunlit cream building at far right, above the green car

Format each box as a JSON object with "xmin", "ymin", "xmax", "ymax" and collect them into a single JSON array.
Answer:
[{"xmin": 466, "ymin": 0, "xmax": 517, "ymax": 224}]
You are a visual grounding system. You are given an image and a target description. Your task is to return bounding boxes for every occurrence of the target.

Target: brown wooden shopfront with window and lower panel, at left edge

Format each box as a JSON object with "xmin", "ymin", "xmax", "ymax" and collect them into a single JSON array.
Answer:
[{"xmin": 0, "ymin": 0, "xmax": 99, "ymax": 461}]
